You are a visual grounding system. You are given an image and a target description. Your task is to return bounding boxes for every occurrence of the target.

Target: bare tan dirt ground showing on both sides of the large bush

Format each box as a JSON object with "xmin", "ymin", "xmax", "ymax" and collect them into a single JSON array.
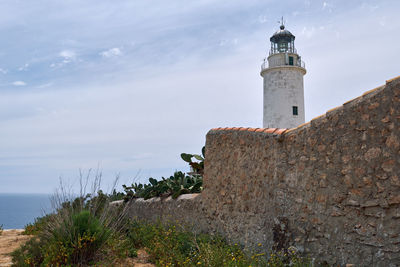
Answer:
[{"xmin": 0, "ymin": 229, "xmax": 155, "ymax": 267}]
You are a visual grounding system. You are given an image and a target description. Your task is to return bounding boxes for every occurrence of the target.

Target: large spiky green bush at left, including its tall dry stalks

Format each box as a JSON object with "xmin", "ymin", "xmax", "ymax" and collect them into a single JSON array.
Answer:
[{"xmin": 12, "ymin": 173, "xmax": 130, "ymax": 266}]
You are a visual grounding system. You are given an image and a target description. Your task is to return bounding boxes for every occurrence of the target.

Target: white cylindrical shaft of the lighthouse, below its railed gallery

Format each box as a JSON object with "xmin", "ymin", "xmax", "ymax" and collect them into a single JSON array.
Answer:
[{"xmin": 261, "ymin": 65, "xmax": 306, "ymax": 128}]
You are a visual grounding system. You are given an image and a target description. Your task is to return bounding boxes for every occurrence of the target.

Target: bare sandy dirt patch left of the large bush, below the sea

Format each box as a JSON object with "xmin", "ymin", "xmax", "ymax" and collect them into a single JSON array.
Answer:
[{"xmin": 0, "ymin": 229, "xmax": 30, "ymax": 267}]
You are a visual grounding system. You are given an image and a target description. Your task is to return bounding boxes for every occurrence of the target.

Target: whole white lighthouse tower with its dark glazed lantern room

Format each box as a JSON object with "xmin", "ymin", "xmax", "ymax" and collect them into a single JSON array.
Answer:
[{"xmin": 260, "ymin": 20, "xmax": 306, "ymax": 128}]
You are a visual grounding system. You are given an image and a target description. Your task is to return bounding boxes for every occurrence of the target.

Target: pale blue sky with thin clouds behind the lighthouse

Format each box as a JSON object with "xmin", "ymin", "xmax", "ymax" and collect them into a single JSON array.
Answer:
[{"xmin": 0, "ymin": 0, "xmax": 400, "ymax": 193}]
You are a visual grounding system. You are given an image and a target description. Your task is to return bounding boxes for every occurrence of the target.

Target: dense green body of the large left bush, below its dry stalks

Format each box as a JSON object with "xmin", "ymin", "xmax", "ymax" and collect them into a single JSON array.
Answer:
[{"xmin": 12, "ymin": 205, "xmax": 127, "ymax": 266}]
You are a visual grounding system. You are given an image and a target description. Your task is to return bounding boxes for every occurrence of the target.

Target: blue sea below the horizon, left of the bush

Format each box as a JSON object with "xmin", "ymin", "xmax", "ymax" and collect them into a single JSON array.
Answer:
[{"xmin": 0, "ymin": 193, "xmax": 51, "ymax": 229}]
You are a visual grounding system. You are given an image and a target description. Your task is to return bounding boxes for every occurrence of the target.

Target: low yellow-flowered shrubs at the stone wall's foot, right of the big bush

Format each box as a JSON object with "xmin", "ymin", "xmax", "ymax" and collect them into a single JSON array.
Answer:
[{"xmin": 128, "ymin": 221, "xmax": 312, "ymax": 267}]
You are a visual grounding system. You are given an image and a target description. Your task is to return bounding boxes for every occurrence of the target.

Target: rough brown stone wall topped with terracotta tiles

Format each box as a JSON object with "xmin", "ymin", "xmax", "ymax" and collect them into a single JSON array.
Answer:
[{"xmin": 127, "ymin": 76, "xmax": 400, "ymax": 266}]
